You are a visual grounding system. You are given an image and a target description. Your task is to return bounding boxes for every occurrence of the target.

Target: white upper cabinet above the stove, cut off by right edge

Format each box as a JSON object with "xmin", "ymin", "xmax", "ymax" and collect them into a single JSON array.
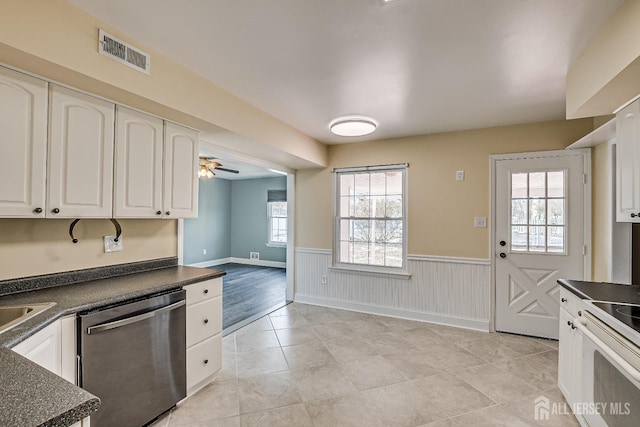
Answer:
[{"xmin": 616, "ymin": 100, "xmax": 640, "ymax": 222}]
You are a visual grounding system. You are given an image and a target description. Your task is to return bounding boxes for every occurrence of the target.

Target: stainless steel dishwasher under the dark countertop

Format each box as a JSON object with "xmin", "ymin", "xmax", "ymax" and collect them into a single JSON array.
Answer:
[{"xmin": 78, "ymin": 290, "xmax": 186, "ymax": 427}]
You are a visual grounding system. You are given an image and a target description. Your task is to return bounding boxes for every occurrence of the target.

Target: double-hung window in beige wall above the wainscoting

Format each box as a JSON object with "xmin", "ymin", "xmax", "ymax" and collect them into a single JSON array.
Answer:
[{"xmin": 334, "ymin": 164, "xmax": 407, "ymax": 273}]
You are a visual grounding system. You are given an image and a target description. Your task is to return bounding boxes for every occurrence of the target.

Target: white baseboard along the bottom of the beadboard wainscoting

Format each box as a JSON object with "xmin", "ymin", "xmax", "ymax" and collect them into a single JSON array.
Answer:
[{"xmin": 293, "ymin": 294, "xmax": 489, "ymax": 332}]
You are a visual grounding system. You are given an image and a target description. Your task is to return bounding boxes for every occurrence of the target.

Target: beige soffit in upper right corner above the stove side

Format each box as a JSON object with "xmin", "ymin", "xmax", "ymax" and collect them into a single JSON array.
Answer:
[{"xmin": 567, "ymin": 0, "xmax": 640, "ymax": 119}]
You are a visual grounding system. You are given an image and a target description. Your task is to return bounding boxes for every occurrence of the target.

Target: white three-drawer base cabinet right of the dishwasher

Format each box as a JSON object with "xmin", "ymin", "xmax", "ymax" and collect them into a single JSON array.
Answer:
[{"xmin": 184, "ymin": 278, "xmax": 222, "ymax": 396}]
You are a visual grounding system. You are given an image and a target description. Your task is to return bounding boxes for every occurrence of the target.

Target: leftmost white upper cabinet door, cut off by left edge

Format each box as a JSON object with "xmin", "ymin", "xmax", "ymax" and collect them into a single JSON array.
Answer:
[{"xmin": 0, "ymin": 68, "xmax": 47, "ymax": 218}]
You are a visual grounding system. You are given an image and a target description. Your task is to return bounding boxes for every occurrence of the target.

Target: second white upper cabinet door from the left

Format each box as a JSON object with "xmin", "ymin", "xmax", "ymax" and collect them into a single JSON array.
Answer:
[{"xmin": 47, "ymin": 85, "xmax": 114, "ymax": 218}]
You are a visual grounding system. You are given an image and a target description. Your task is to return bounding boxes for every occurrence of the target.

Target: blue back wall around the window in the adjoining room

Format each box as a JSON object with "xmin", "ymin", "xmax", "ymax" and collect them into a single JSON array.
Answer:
[{"xmin": 231, "ymin": 176, "xmax": 287, "ymax": 261}]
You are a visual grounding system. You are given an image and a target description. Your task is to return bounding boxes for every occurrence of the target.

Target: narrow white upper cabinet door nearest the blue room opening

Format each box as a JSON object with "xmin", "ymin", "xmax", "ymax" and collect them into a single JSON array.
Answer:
[{"xmin": 163, "ymin": 122, "xmax": 199, "ymax": 218}]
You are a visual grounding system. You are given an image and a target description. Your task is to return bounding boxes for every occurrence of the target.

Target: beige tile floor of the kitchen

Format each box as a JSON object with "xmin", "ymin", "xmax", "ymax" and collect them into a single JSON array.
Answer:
[{"xmin": 154, "ymin": 303, "xmax": 578, "ymax": 427}]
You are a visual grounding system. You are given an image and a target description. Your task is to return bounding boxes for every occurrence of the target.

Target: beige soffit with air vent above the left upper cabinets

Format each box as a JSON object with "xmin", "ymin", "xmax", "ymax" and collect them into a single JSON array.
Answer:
[{"xmin": 0, "ymin": 0, "xmax": 326, "ymax": 169}]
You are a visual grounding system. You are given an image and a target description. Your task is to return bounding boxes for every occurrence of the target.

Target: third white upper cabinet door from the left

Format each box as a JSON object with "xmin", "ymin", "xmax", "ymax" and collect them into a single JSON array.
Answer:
[{"xmin": 113, "ymin": 106, "xmax": 163, "ymax": 218}]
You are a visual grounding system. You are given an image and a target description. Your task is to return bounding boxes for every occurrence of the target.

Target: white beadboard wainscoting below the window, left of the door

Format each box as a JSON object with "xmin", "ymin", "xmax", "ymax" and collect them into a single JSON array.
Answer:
[{"xmin": 294, "ymin": 248, "xmax": 491, "ymax": 331}]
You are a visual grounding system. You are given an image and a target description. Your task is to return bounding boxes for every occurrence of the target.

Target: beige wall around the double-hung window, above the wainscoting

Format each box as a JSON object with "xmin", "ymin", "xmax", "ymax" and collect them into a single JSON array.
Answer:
[{"xmin": 296, "ymin": 120, "xmax": 593, "ymax": 258}]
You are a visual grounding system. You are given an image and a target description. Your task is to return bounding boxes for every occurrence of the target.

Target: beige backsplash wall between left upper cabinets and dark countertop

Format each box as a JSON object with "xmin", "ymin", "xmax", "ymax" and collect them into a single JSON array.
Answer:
[{"xmin": 0, "ymin": 219, "xmax": 177, "ymax": 280}]
